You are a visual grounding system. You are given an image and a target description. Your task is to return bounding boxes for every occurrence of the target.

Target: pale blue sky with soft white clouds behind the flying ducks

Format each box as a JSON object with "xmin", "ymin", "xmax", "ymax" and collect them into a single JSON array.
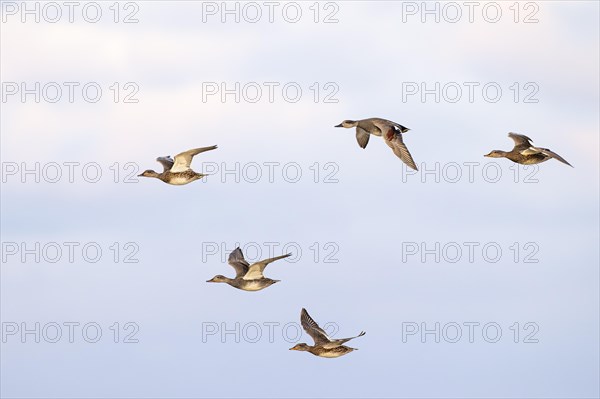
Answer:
[{"xmin": 0, "ymin": 1, "xmax": 600, "ymax": 398}]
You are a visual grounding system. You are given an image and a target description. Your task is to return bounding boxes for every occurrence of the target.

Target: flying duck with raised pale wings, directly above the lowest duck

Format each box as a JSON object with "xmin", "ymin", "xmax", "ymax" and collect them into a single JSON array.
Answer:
[{"xmin": 206, "ymin": 247, "xmax": 292, "ymax": 291}]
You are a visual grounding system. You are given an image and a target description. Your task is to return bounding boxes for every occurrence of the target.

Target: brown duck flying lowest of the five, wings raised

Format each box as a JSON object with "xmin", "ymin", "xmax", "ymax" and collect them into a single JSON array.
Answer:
[{"xmin": 290, "ymin": 308, "xmax": 365, "ymax": 358}]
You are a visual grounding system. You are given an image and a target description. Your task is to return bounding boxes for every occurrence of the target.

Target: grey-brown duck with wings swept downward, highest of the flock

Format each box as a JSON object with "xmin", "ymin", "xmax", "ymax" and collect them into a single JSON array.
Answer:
[{"xmin": 335, "ymin": 118, "xmax": 418, "ymax": 170}]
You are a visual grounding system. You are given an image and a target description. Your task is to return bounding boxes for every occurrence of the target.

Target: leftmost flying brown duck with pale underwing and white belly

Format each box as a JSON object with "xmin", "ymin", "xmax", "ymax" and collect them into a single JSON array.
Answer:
[{"xmin": 138, "ymin": 145, "xmax": 217, "ymax": 186}]
